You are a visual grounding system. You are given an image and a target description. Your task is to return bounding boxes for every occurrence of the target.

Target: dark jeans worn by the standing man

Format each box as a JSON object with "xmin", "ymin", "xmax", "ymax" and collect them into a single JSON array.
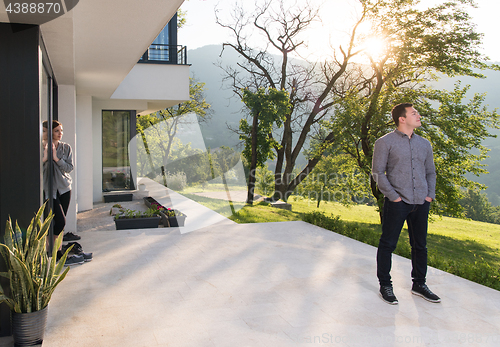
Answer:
[{"xmin": 377, "ymin": 198, "xmax": 430, "ymax": 286}]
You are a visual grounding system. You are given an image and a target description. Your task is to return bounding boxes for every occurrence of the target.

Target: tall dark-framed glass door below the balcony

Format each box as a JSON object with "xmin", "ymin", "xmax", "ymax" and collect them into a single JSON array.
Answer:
[{"xmin": 102, "ymin": 111, "xmax": 132, "ymax": 192}]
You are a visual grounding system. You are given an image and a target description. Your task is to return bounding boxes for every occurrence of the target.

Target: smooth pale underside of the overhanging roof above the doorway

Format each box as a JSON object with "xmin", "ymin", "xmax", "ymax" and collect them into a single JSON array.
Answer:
[{"xmin": 0, "ymin": 0, "xmax": 184, "ymax": 98}]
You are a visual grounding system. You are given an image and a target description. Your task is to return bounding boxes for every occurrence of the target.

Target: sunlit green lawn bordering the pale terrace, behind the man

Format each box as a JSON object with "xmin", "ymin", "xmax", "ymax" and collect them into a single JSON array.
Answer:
[{"xmin": 177, "ymin": 192, "xmax": 500, "ymax": 290}]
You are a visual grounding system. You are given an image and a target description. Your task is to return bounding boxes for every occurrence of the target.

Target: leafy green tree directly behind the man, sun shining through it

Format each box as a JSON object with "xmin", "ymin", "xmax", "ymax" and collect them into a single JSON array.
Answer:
[{"xmin": 318, "ymin": 1, "xmax": 499, "ymax": 222}]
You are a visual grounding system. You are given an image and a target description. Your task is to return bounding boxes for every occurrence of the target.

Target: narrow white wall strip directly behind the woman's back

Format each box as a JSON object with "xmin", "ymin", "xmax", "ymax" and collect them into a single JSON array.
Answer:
[{"xmin": 58, "ymin": 85, "xmax": 78, "ymax": 232}]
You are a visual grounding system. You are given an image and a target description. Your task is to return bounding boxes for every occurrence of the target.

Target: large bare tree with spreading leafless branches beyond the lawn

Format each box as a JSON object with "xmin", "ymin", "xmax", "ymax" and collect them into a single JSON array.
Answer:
[{"xmin": 216, "ymin": 0, "xmax": 366, "ymax": 201}]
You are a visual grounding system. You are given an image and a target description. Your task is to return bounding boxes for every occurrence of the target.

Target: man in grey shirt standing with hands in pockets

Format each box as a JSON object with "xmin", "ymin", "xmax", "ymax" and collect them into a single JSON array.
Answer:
[{"xmin": 372, "ymin": 103, "xmax": 441, "ymax": 305}]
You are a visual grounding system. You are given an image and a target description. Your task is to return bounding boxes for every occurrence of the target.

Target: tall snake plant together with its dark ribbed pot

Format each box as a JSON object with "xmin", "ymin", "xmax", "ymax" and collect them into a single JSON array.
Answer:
[{"xmin": 0, "ymin": 204, "xmax": 71, "ymax": 346}]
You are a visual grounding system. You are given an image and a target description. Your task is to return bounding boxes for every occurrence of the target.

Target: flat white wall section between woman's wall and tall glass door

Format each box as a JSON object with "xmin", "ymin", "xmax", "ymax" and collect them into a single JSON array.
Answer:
[{"xmin": 76, "ymin": 95, "xmax": 94, "ymax": 212}]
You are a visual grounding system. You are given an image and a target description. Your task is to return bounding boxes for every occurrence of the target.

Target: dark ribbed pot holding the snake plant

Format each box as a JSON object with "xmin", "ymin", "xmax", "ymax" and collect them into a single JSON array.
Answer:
[{"xmin": 12, "ymin": 306, "xmax": 48, "ymax": 346}]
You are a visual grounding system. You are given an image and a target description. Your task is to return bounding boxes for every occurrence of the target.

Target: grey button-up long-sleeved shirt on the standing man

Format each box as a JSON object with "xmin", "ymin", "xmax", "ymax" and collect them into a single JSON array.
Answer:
[{"xmin": 372, "ymin": 129, "xmax": 436, "ymax": 205}]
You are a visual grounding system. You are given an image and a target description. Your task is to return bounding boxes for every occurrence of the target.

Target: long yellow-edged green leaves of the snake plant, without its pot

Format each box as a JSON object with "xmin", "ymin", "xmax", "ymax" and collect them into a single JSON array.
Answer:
[{"xmin": 0, "ymin": 204, "xmax": 71, "ymax": 313}]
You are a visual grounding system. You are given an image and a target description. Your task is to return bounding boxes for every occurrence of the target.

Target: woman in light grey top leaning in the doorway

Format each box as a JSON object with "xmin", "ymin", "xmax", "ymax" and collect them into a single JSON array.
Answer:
[{"xmin": 43, "ymin": 120, "xmax": 90, "ymax": 265}]
